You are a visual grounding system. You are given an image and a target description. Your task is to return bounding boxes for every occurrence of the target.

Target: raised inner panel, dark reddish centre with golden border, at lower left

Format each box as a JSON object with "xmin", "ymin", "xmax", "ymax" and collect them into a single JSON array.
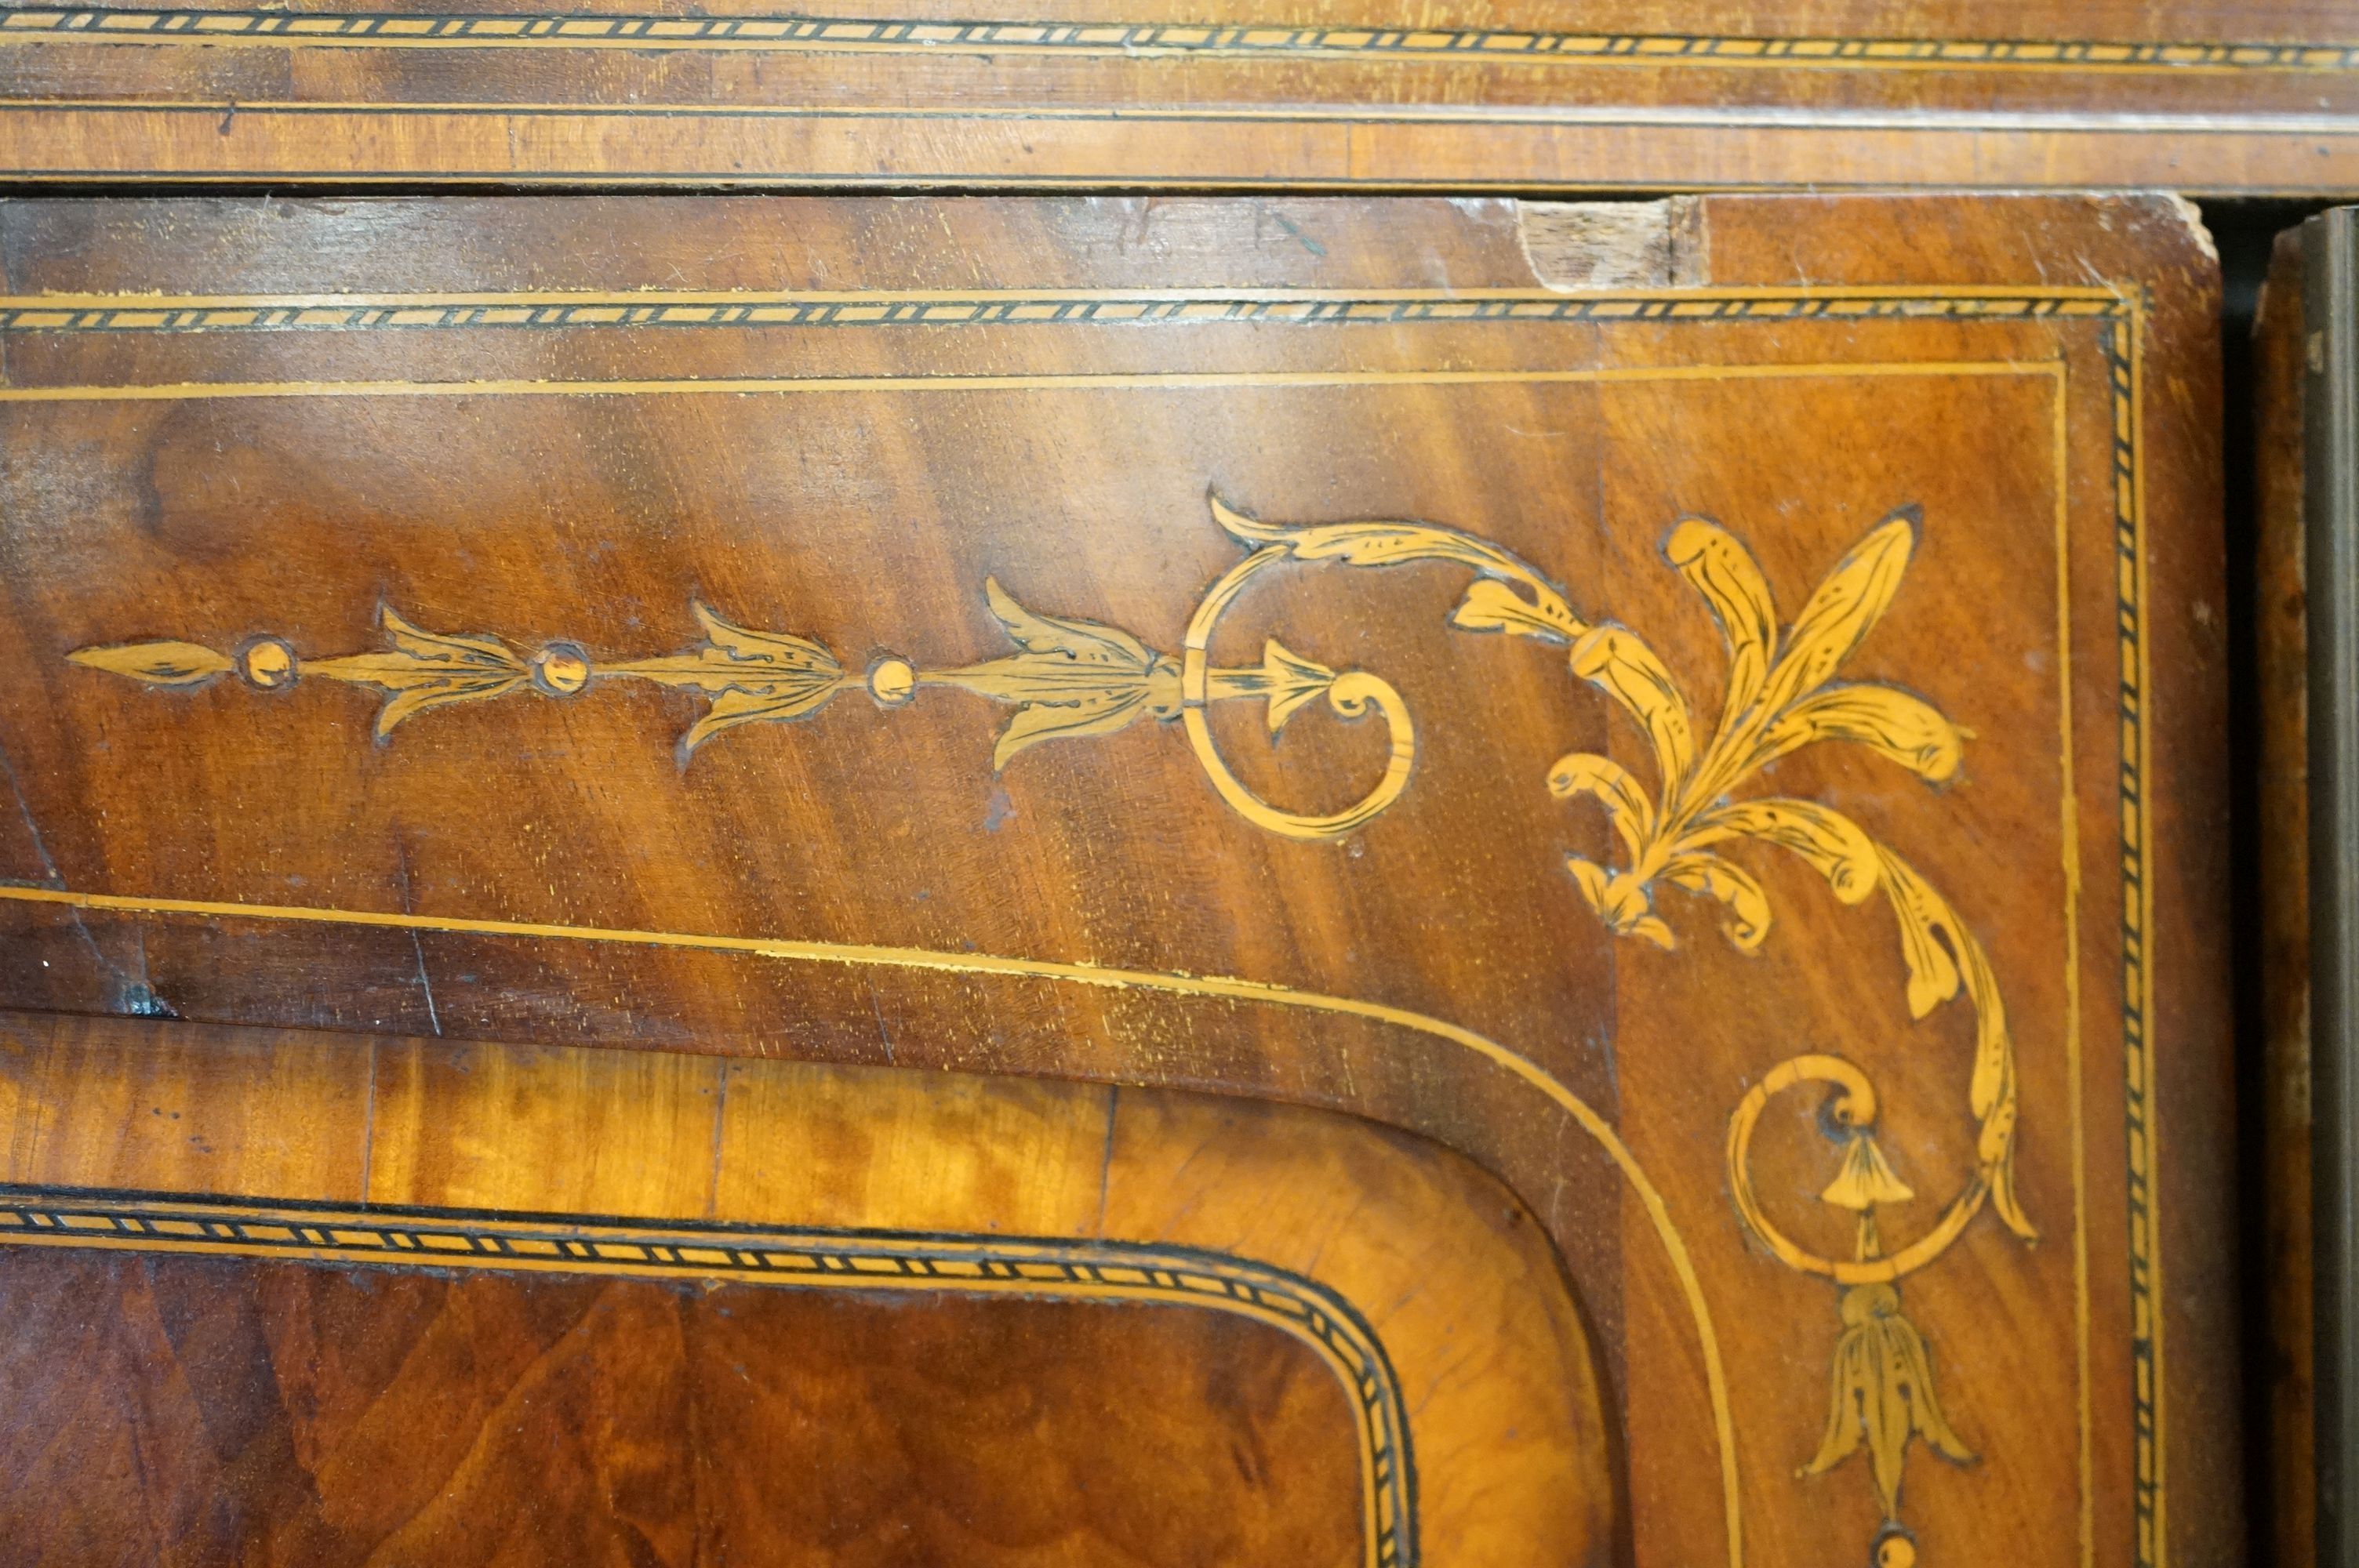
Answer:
[{"xmin": 0, "ymin": 1016, "xmax": 1613, "ymax": 1566}]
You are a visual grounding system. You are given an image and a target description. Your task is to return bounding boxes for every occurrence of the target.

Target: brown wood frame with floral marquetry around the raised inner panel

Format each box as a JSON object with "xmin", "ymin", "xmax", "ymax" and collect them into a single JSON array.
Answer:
[{"xmin": 0, "ymin": 196, "xmax": 2234, "ymax": 1566}]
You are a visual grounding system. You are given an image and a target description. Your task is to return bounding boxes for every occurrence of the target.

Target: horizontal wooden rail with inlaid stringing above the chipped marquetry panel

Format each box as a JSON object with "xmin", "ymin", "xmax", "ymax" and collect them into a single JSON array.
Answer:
[{"xmin": 0, "ymin": 0, "xmax": 2359, "ymax": 194}]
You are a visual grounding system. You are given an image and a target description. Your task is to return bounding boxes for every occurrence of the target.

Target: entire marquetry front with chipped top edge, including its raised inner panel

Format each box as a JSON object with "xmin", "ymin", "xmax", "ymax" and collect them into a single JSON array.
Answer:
[{"xmin": 0, "ymin": 196, "xmax": 2234, "ymax": 1568}]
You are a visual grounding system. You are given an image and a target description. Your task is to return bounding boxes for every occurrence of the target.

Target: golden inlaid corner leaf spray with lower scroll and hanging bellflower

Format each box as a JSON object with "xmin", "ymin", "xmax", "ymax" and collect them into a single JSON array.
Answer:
[{"xmin": 1189, "ymin": 500, "xmax": 2036, "ymax": 1540}]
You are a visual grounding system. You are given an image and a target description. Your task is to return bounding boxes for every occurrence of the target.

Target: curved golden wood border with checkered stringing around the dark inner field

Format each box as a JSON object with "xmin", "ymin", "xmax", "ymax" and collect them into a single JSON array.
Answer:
[{"xmin": 0, "ymin": 1014, "xmax": 1611, "ymax": 1568}]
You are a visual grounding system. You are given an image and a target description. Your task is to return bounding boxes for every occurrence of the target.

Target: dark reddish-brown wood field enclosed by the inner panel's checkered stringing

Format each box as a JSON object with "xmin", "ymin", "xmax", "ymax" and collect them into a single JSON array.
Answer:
[{"xmin": 0, "ymin": 1250, "xmax": 1361, "ymax": 1568}]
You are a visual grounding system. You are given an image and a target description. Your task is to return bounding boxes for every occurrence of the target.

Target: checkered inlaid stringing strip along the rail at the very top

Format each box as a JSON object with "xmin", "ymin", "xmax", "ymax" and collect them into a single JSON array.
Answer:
[{"xmin": 0, "ymin": 7, "xmax": 2359, "ymax": 71}]
